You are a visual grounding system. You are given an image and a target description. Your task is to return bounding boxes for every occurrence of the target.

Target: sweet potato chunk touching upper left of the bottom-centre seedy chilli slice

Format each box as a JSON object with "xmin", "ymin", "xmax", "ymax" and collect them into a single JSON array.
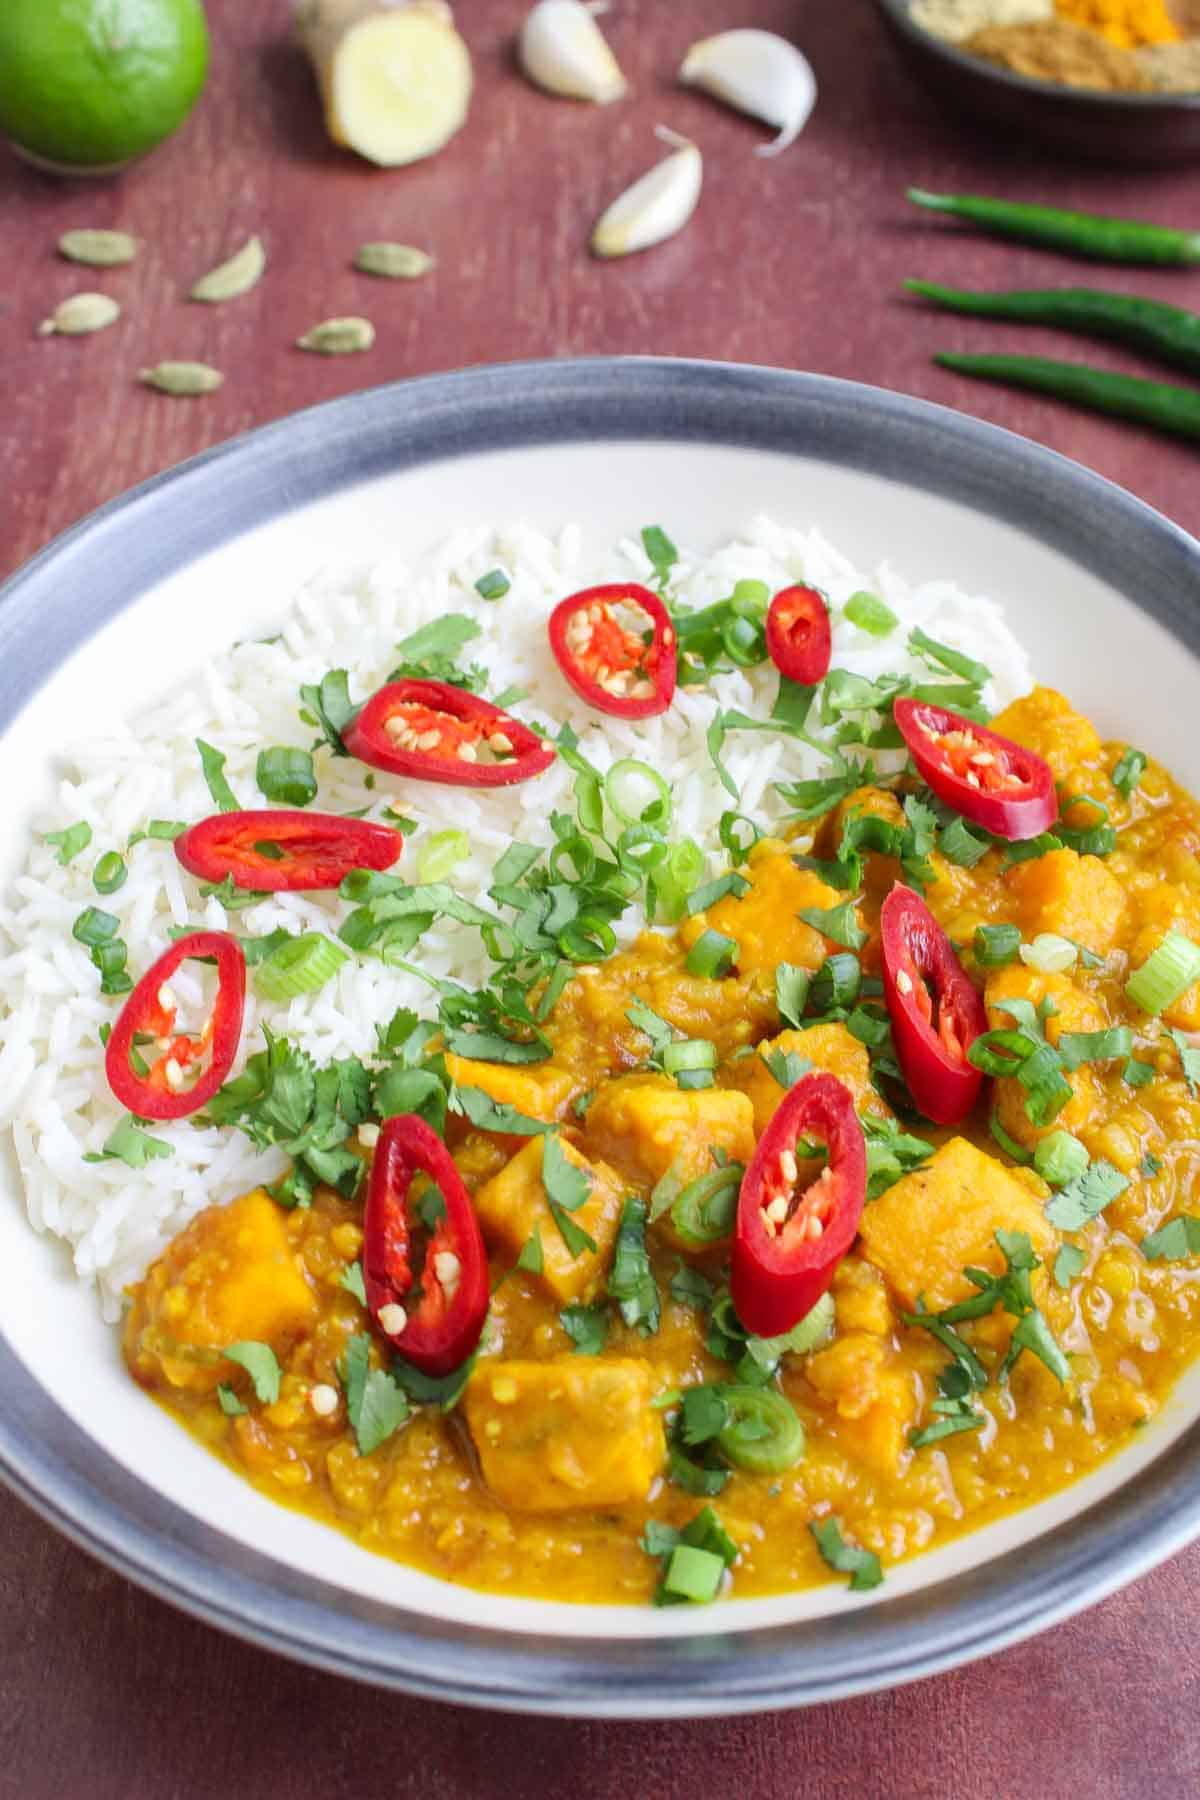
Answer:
[{"xmin": 585, "ymin": 1058, "xmax": 755, "ymax": 1186}]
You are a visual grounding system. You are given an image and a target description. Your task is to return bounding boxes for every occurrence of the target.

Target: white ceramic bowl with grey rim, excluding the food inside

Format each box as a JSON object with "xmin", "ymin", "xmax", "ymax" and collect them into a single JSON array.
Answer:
[{"xmin": 0, "ymin": 360, "xmax": 1200, "ymax": 1715}]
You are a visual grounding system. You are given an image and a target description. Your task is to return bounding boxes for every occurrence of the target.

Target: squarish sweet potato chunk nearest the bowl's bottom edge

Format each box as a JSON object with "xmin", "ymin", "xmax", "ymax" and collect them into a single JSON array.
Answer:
[{"xmin": 466, "ymin": 1357, "xmax": 666, "ymax": 1512}]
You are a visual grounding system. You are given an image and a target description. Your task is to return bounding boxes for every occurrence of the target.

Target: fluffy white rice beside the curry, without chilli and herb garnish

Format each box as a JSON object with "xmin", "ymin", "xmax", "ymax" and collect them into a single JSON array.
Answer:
[{"xmin": 0, "ymin": 518, "xmax": 1029, "ymax": 1318}]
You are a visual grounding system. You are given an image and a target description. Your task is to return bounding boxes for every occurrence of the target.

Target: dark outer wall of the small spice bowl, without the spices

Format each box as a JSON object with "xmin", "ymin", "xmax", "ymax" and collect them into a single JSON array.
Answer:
[{"xmin": 878, "ymin": 0, "xmax": 1200, "ymax": 164}]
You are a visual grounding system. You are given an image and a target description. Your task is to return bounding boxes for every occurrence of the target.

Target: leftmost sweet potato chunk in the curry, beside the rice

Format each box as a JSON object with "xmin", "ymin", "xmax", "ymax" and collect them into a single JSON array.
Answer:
[{"xmin": 124, "ymin": 1188, "xmax": 317, "ymax": 1391}]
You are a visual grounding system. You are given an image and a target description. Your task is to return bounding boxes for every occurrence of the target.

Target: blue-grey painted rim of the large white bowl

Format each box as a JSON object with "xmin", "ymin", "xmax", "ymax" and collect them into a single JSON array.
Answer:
[{"xmin": 0, "ymin": 356, "xmax": 1200, "ymax": 1719}]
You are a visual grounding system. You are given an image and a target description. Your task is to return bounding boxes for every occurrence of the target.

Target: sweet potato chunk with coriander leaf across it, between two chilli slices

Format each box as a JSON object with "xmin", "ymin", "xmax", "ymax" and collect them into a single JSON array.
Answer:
[{"xmin": 475, "ymin": 1138, "xmax": 624, "ymax": 1303}]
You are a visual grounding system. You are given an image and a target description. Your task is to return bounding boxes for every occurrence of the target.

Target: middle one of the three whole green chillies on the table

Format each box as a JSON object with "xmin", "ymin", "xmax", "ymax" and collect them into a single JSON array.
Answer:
[{"xmin": 905, "ymin": 281, "xmax": 1200, "ymax": 373}]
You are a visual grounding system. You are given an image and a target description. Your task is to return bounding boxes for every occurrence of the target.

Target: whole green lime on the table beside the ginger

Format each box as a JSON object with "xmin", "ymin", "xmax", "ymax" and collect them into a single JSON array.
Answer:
[{"xmin": 0, "ymin": 0, "xmax": 209, "ymax": 173}]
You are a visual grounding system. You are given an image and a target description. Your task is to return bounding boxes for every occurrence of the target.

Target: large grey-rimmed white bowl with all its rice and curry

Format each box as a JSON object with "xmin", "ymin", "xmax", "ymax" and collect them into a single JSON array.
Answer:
[{"xmin": 0, "ymin": 362, "xmax": 1200, "ymax": 1714}]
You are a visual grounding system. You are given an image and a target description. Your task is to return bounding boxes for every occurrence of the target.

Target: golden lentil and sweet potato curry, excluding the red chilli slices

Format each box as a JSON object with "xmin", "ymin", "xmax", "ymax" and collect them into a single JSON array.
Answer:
[{"xmin": 124, "ymin": 689, "xmax": 1200, "ymax": 1602}]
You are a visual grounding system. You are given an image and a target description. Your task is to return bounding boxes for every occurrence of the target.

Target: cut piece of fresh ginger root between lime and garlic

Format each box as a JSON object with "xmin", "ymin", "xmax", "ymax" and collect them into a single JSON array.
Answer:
[{"xmin": 295, "ymin": 0, "xmax": 471, "ymax": 167}]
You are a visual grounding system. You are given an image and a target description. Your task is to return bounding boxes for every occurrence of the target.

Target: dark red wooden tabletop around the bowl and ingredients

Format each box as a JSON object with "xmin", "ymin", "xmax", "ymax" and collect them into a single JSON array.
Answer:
[{"xmin": 0, "ymin": 0, "xmax": 1200, "ymax": 1800}]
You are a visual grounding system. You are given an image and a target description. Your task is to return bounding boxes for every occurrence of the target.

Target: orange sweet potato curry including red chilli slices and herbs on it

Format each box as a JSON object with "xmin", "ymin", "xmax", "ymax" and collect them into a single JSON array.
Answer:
[{"xmin": 124, "ymin": 689, "xmax": 1200, "ymax": 1602}]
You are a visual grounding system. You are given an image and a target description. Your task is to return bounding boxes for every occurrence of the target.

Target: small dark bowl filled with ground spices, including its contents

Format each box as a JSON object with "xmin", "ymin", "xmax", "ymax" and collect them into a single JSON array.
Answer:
[{"xmin": 878, "ymin": 0, "xmax": 1200, "ymax": 164}]
